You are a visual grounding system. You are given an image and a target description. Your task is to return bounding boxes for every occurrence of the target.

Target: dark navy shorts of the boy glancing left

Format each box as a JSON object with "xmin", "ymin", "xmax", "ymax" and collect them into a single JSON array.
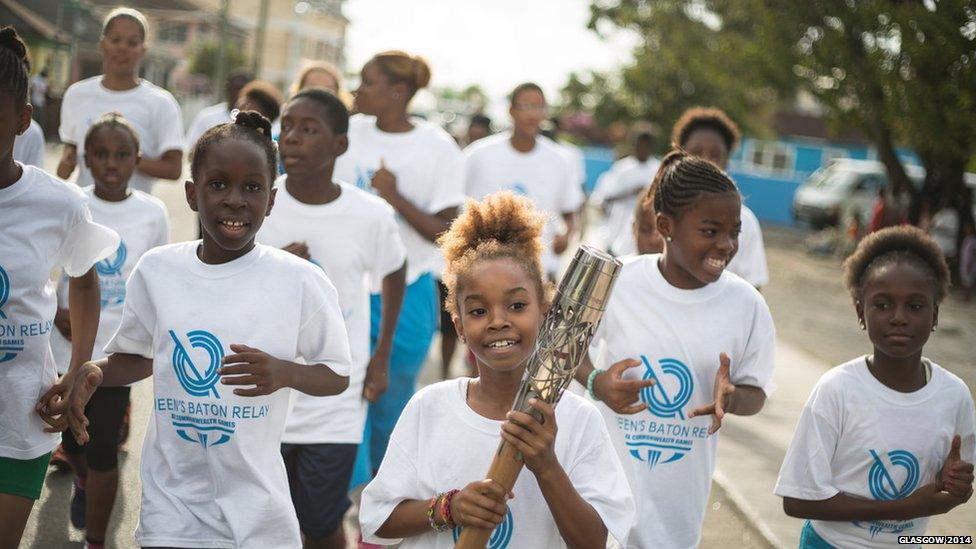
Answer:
[{"xmin": 281, "ymin": 444, "xmax": 359, "ymax": 539}]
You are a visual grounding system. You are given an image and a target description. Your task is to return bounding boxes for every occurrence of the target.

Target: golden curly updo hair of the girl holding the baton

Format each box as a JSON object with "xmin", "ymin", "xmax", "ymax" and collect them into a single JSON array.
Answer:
[{"xmin": 437, "ymin": 191, "xmax": 550, "ymax": 317}]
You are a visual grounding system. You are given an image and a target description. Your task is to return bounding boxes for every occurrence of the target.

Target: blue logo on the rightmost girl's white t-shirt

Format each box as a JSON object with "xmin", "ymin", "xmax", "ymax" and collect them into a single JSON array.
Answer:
[{"xmin": 854, "ymin": 450, "xmax": 919, "ymax": 538}]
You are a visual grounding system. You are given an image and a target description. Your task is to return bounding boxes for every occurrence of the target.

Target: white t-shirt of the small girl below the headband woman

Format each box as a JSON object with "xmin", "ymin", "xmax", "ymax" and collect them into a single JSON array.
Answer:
[{"xmin": 51, "ymin": 187, "xmax": 169, "ymax": 374}]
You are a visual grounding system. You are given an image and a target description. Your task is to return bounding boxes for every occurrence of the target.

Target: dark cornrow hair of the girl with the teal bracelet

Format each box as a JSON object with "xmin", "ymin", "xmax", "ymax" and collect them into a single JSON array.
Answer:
[{"xmin": 644, "ymin": 149, "xmax": 739, "ymax": 218}]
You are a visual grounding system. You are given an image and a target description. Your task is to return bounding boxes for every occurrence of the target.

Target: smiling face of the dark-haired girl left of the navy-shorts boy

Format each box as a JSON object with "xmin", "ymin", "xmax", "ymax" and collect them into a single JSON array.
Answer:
[{"xmin": 185, "ymin": 139, "xmax": 275, "ymax": 263}]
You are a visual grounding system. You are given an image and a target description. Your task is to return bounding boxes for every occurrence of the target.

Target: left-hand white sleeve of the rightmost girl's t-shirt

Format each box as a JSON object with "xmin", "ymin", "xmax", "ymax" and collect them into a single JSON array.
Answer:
[{"xmin": 773, "ymin": 379, "xmax": 842, "ymax": 501}]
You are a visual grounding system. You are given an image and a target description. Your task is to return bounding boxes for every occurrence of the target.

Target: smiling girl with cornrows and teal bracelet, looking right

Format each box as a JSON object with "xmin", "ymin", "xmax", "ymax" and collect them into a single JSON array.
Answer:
[{"xmin": 577, "ymin": 151, "xmax": 775, "ymax": 548}]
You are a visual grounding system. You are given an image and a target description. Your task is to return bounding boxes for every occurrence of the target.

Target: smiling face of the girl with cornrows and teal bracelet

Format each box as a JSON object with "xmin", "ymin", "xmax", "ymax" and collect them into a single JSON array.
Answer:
[{"xmin": 657, "ymin": 193, "xmax": 742, "ymax": 290}]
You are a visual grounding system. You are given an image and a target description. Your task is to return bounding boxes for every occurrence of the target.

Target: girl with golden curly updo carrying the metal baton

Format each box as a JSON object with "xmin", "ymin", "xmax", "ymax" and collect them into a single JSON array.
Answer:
[{"xmin": 359, "ymin": 192, "xmax": 633, "ymax": 549}]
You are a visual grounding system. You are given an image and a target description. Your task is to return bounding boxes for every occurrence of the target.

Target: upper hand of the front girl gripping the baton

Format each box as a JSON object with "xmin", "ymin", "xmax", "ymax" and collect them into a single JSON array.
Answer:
[{"xmin": 502, "ymin": 398, "xmax": 559, "ymax": 476}]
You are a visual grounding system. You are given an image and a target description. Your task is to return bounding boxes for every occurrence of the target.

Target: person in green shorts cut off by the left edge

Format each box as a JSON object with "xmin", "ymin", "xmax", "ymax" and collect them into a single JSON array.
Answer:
[{"xmin": 0, "ymin": 27, "xmax": 119, "ymax": 547}]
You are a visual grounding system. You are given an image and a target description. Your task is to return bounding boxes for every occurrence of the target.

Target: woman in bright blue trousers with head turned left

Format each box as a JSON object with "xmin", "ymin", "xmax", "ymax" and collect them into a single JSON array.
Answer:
[{"xmin": 335, "ymin": 51, "xmax": 464, "ymax": 485}]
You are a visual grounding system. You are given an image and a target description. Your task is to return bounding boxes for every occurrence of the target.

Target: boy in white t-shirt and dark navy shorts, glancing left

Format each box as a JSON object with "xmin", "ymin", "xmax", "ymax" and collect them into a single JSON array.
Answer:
[{"xmin": 258, "ymin": 88, "xmax": 406, "ymax": 549}]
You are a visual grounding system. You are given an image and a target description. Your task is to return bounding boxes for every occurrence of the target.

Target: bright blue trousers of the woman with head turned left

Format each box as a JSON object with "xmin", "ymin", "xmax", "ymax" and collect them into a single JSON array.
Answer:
[{"xmin": 350, "ymin": 273, "xmax": 440, "ymax": 487}]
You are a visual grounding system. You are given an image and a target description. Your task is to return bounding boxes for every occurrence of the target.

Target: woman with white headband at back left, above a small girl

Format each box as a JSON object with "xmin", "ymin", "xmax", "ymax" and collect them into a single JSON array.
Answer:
[{"xmin": 58, "ymin": 8, "xmax": 183, "ymax": 193}]
